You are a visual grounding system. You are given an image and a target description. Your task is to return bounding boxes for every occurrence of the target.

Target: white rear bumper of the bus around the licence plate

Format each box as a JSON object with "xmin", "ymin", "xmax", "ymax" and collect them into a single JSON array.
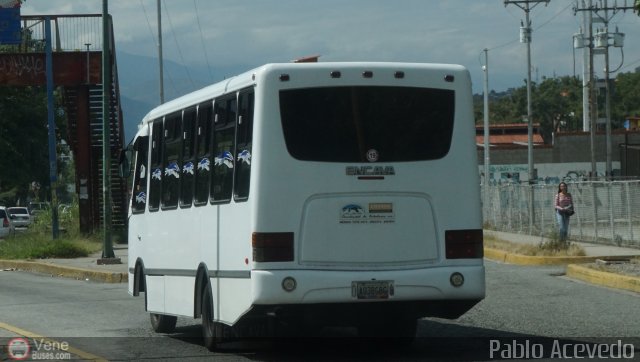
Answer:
[{"xmin": 251, "ymin": 265, "xmax": 485, "ymax": 318}]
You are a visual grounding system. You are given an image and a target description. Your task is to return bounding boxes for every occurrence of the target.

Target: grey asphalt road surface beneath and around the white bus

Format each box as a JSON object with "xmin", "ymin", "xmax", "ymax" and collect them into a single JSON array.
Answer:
[{"xmin": 0, "ymin": 261, "xmax": 640, "ymax": 361}]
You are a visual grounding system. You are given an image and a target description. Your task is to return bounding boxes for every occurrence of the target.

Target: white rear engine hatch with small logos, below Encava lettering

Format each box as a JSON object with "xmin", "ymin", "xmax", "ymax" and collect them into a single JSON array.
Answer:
[{"xmin": 298, "ymin": 192, "xmax": 438, "ymax": 269}]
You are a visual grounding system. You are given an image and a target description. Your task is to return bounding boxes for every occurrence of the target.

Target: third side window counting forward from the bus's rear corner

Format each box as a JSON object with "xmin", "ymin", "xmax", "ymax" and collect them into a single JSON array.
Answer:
[{"xmin": 194, "ymin": 101, "xmax": 213, "ymax": 205}]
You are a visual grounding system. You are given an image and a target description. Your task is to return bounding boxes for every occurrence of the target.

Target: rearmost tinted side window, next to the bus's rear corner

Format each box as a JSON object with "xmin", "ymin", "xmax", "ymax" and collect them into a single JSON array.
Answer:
[{"xmin": 233, "ymin": 90, "xmax": 254, "ymax": 201}]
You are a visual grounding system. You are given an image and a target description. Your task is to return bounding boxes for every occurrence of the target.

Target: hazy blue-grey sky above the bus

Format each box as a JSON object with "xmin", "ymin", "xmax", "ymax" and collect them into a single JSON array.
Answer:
[{"xmin": 21, "ymin": 0, "xmax": 640, "ymax": 93}]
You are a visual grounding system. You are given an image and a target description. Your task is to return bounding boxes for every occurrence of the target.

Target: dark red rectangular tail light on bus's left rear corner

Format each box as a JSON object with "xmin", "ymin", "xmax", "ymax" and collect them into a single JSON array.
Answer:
[{"xmin": 251, "ymin": 232, "xmax": 293, "ymax": 263}]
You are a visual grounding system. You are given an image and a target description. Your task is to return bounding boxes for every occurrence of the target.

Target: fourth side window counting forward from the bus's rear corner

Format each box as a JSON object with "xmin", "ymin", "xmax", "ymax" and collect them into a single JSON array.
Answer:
[{"xmin": 180, "ymin": 108, "xmax": 196, "ymax": 207}]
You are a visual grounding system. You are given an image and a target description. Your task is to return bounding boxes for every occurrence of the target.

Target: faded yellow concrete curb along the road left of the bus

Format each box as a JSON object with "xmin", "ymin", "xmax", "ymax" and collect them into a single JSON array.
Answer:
[{"xmin": 0, "ymin": 260, "xmax": 129, "ymax": 283}]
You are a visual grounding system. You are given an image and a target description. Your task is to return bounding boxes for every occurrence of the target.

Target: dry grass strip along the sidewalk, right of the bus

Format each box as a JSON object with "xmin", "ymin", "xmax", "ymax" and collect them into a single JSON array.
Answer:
[{"xmin": 484, "ymin": 236, "xmax": 586, "ymax": 256}]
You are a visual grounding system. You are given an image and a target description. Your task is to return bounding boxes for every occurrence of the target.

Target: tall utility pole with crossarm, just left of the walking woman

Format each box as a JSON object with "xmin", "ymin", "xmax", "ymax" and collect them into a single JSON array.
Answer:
[{"xmin": 504, "ymin": 0, "xmax": 550, "ymax": 230}]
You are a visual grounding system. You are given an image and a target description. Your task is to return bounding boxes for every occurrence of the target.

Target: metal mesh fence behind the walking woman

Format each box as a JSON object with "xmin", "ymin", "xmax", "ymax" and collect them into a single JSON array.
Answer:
[{"xmin": 482, "ymin": 180, "xmax": 640, "ymax": 247}]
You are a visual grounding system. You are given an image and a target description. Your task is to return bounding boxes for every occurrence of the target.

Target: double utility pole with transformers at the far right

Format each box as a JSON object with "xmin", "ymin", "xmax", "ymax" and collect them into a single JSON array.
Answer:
[{"xmin": 574, "ymin": 0, "xmax": 634, "ymax": 178}]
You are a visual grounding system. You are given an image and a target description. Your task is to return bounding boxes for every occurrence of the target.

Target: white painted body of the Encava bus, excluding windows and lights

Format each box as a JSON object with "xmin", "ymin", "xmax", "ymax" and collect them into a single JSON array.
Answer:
[{"xmin": 129, "ymin": 63, "xmax": 485, "ymax": 324}]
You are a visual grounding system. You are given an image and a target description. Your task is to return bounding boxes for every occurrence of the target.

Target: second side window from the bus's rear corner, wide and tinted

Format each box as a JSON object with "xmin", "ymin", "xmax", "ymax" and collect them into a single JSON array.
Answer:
[{"xmin": 211, "ymin": 94, "xmax": 238, "ymax": 203}]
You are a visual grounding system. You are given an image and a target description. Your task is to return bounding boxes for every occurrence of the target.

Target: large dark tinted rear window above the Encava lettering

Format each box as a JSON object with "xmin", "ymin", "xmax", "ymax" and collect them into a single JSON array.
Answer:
[{"xmin": 280, "ymin": 87, "xmax": 455, "ymax": 162}]
